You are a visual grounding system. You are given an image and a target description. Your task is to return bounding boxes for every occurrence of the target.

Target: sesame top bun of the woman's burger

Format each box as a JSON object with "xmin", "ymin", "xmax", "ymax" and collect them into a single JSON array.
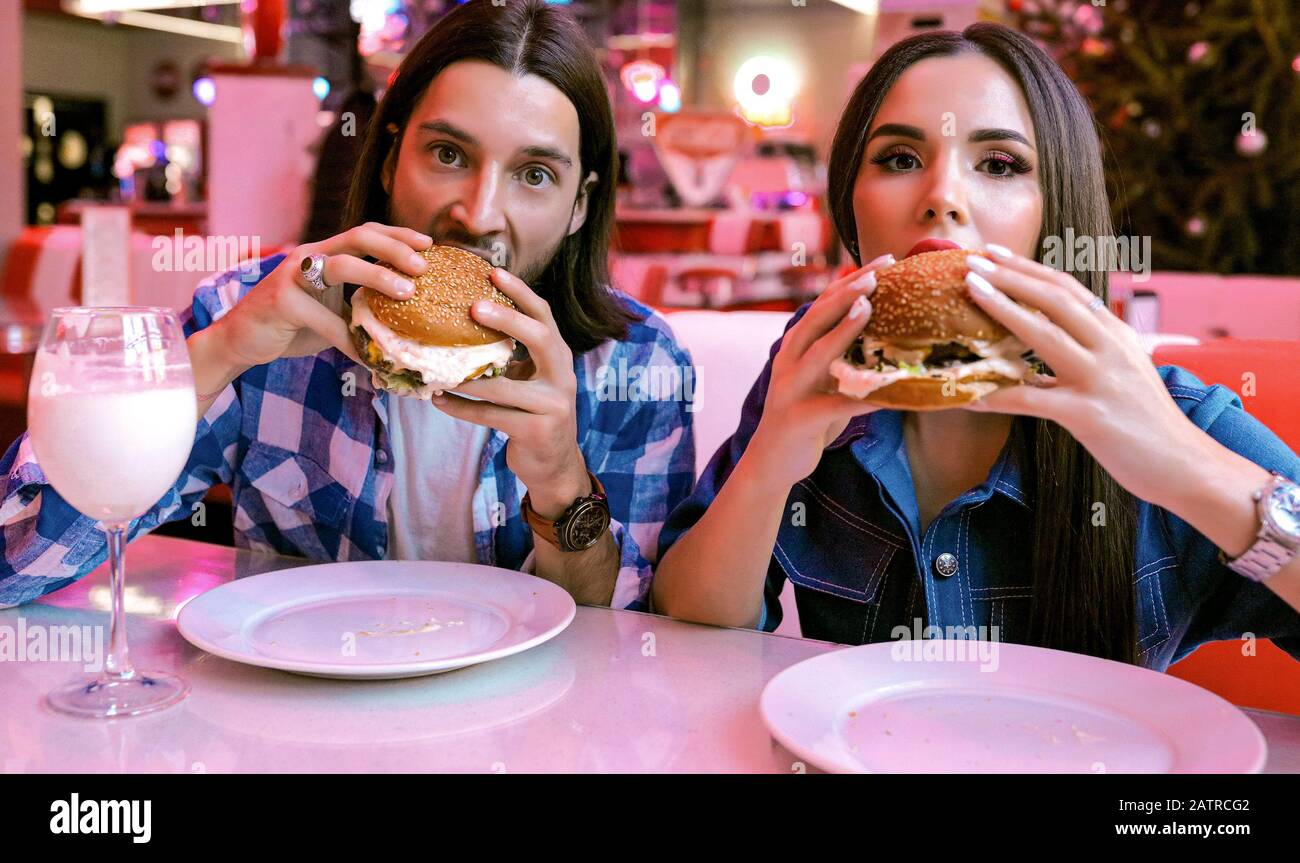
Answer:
[{"xmin": 866, "ymin": 248, "xmax": 1008, "ymax": 348}]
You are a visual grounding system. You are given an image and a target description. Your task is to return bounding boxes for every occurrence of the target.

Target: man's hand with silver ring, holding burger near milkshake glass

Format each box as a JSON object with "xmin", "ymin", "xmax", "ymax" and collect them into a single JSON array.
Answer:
[{"xmin": 189, "ymin": 222, "xmax": 433, "ymax": 416}]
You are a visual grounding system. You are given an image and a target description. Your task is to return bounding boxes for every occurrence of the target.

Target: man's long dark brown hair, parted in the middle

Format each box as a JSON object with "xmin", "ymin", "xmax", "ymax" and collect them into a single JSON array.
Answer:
[{"xmin": 343, "ymin": 0, "xmax": 640, "ymax": 355}]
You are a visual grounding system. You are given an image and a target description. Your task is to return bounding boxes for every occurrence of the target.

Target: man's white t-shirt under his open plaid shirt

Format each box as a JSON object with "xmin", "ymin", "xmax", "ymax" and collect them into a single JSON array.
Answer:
[{"xmin": 387, "ymin": 395, "xmax": 489, "ymax": 563}]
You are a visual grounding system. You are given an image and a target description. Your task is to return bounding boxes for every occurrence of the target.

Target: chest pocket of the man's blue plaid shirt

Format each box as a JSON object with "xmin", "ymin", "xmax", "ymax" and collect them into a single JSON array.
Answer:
[{"xmin": 241, "ymin": 441, "xmax": 352, "ymax": 529}]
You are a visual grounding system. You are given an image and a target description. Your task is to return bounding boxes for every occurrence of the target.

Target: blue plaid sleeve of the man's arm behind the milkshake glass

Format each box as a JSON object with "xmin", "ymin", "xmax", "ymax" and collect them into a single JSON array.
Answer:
[{"xmin": 0, "ymin": 261, "xmax": 260, "ymax": 607}]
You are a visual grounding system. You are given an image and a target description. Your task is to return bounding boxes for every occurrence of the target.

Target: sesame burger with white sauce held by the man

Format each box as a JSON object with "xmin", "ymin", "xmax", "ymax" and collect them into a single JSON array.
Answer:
[{"xmin": 348, "ymin": 246, "xmax": 515, "ymax": 399}]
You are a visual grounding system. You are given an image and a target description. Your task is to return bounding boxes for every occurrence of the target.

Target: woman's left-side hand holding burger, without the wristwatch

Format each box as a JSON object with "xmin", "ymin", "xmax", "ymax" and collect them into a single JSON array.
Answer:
[{"xmin": 745, "ymin": 255, "xmax": 894, "ymax": 487}]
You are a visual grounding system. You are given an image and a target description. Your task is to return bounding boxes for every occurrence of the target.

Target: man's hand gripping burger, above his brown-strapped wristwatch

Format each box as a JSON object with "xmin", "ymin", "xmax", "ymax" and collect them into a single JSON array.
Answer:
[{"xmin": 433, "ymin": 266, "xmax": 592, "ymax": 520}]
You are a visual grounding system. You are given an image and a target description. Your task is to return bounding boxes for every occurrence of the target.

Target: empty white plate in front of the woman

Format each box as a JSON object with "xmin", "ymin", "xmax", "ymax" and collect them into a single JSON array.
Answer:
[{"xmin": 761, "ymin": 639, "xmax": 1268, "ymax": 773}]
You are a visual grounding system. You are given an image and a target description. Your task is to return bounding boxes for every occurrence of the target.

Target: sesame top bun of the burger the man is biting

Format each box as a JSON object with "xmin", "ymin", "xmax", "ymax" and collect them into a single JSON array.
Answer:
[{"xmin": 365, "ymin": 246, "xmax": 515, "ymax": 347}]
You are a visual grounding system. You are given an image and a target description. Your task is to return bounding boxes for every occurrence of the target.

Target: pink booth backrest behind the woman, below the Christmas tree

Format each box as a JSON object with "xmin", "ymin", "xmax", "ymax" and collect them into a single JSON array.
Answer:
[{"xmin": 1112, "ymin": 272, "xmax": 1300, "ymax": 341}]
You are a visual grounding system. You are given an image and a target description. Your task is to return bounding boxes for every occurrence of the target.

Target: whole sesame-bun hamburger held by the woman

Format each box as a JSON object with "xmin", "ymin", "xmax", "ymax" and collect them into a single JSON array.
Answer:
[{"xmin": 831, "ymin": 240, "xmax": 1036, "ymax": 411}]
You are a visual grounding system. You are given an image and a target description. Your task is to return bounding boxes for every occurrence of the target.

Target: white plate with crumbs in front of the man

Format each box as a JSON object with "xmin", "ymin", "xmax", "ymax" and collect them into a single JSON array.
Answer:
[{"xmin": 177, "ymin": 560, "xmax": 577, "ymax": 680}]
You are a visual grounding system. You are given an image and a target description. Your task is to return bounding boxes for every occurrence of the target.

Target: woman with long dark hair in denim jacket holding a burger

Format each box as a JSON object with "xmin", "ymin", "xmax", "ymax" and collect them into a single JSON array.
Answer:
[{"xmin": 653, "ymin": 23, "xmax": 1300, "ymax": 669}]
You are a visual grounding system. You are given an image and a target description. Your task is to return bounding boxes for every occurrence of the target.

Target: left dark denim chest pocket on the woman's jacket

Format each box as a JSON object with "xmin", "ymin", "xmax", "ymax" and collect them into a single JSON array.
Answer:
[{"xmin": 774, "ymin": 480, "xmax": 905, "ymax": 603}]
